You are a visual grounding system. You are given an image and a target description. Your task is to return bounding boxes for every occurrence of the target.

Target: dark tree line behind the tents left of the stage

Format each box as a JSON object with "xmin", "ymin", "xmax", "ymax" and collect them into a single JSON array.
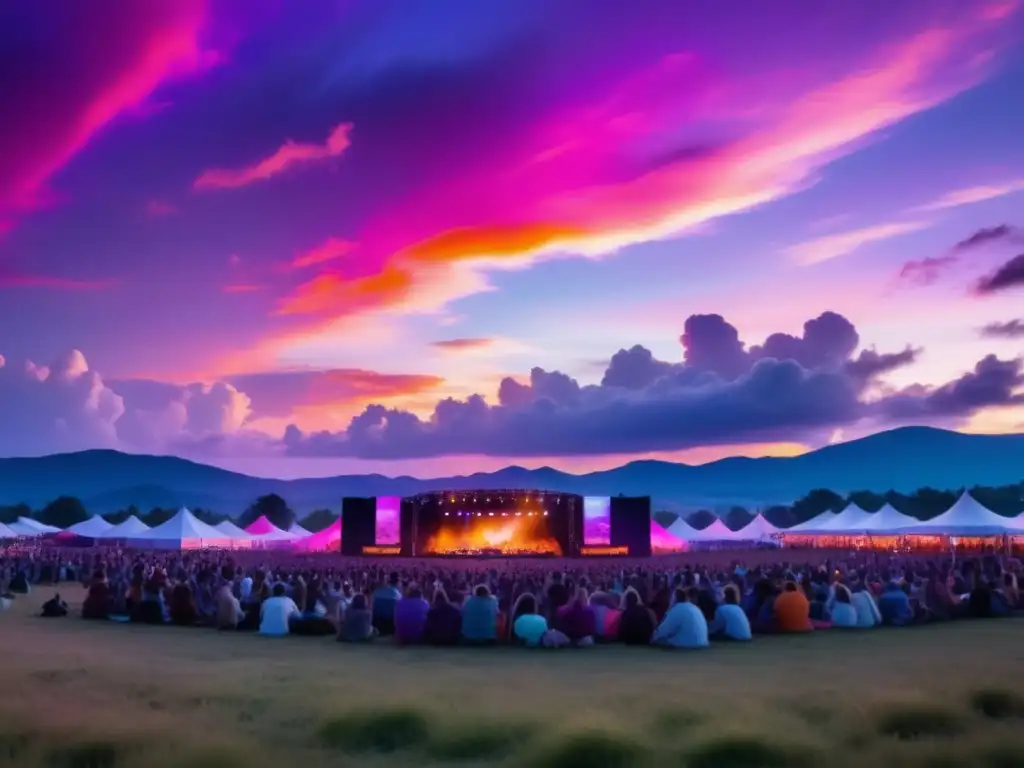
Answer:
[{"xmin": 0, "ymin": 494, "xmax": 339, "ymax": 532}]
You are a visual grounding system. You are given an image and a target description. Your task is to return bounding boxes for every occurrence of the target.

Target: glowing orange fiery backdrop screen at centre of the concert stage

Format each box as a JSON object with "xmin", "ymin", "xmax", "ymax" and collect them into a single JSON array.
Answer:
[{"xmin": 423, "ymin": 509, "xmax": 562, "ymax": 556}]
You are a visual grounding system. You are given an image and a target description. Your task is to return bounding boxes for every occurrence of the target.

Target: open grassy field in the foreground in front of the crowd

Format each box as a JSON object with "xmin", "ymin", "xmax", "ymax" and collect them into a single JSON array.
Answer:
[{"xmin": 0, "ymin": 590, "xmax": 1024, "ymax": 768}]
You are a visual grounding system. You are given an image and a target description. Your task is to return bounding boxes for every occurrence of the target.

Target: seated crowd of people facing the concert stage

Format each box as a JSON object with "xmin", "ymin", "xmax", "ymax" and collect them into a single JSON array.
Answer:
[{"xmin": 0, "ymin": 549, "xmax": 1024, "ymax": 648}]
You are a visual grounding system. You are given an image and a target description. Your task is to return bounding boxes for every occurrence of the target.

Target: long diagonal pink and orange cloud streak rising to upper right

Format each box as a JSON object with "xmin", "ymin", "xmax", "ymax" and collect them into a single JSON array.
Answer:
[{"xmin": 280, "ymin": 6, "xmax": 1015, "ymax": 325}]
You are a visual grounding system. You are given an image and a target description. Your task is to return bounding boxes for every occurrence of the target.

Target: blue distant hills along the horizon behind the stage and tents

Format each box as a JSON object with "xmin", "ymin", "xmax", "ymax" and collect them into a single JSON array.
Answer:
[{"xmin": 0, "ymin": 427, "xmax": 1024, "ymax": 515}]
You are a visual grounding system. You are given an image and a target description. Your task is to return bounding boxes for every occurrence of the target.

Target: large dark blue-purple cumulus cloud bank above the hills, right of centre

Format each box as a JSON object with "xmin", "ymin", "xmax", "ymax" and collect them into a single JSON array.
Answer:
[{"xmin": 284, "ymin": 312, "xmax": 978, "ymax": 459}]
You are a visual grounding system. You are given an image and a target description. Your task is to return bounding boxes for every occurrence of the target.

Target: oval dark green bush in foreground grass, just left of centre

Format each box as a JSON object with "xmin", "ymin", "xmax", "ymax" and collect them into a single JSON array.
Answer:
[{"xmin": 319, "ymin": 710, "xmax": 430, "ymax": 753}]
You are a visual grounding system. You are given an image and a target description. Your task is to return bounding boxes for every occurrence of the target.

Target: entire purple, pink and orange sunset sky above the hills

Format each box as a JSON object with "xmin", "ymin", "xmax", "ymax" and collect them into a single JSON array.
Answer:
[{"xmin": 0, "ymin": 0, "xmax": 1024, "ymax": 477}]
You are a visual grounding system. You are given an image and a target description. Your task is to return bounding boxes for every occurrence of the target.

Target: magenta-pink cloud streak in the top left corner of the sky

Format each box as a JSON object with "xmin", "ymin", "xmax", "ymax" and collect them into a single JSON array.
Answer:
[{"xmin": 0, "ymin": 0, "xmax": 218, "ymax": 224}]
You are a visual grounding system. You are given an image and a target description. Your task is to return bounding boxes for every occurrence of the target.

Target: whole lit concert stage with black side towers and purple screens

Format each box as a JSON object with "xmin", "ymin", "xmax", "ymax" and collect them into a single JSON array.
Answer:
[{"xmin": 341, "ymin": 488, "xmax": 651, "ymax": 558}]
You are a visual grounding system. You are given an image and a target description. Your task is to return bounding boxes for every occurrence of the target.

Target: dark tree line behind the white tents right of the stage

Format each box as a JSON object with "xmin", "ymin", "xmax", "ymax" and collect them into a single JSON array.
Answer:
[{"xmin": 654, "ymin": 482, "xmax": 1024, "ymax": 530}]
